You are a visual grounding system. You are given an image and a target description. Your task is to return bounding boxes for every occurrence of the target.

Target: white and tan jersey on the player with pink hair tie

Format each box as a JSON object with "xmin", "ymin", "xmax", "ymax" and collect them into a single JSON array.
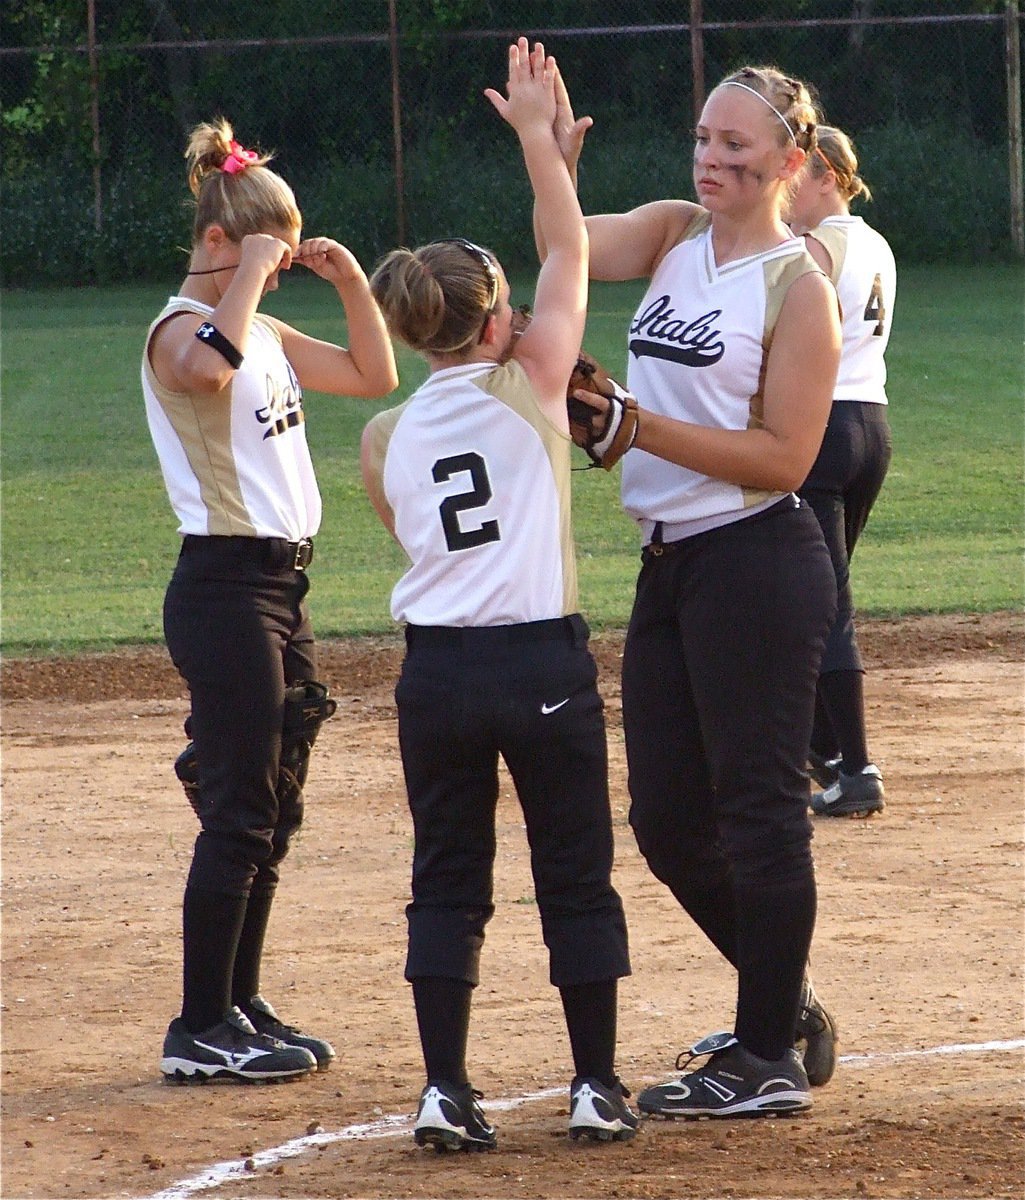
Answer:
[{"xmin": 142, "ymin": 296, "xmax": 320, "ymax": 541}]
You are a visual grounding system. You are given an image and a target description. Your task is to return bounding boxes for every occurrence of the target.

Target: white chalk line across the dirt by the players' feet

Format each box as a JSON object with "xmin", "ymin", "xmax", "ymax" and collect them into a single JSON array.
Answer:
[{"xmin": 149, "ymin": 1038, "xmax": 1025, "ymax": 1200}]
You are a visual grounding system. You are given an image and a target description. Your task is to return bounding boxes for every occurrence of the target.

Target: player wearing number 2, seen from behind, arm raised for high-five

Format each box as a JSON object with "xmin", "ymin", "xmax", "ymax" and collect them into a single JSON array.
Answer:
[{"xmin": 362, "ymin": 38, "xmax": 637, "ymax": 1150}]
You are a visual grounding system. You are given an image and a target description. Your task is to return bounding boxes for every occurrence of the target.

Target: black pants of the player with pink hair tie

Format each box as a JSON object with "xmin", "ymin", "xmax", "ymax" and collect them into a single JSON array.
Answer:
[{"xmin": 163, "ymin": 536, "xmax": 316, "ymax": 896}]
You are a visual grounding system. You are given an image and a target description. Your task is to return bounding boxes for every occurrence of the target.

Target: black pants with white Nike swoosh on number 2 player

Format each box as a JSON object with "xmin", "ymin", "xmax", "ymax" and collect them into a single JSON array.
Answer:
[{"xmin": 395, "ymin": 614, "xmax": 630, "ymax": 988}]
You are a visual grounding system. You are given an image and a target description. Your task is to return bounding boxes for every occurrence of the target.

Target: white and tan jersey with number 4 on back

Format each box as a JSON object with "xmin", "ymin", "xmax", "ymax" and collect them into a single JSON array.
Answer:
[{"xmin": 809, "ymin": 216, "xmax": 897, "ymax": 404}]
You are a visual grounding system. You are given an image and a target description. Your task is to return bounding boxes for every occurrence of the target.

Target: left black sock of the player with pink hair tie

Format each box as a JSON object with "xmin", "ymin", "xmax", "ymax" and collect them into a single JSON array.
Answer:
[{"xmin": 181, "ymin": 887, "xmax": 246, "ymax": 1033}]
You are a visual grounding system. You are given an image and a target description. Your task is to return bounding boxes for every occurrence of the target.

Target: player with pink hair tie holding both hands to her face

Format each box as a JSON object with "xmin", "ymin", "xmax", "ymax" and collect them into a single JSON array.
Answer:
[{"xmin": 142, "ymin": 120, "xmax": 397, "ymax": 1081}]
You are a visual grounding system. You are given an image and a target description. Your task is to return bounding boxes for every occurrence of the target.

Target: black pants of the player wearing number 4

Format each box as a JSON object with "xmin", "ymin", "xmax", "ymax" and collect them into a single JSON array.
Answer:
[{"xmin": 799, "ymin": 400, "xmax": 893, "ymax": 674}]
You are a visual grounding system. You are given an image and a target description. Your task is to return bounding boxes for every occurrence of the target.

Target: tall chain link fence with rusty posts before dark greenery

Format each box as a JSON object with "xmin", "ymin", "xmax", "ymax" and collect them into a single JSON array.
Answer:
[{"xmin": 0, "ymin": 0, "xmax": 1021, "ymax": 286}]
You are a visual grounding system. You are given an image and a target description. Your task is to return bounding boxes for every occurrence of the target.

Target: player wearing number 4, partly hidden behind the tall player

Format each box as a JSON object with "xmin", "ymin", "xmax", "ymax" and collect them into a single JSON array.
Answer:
[{"xmin": 790, "ymin": 126, "xmax": 897, "ymax": 816}]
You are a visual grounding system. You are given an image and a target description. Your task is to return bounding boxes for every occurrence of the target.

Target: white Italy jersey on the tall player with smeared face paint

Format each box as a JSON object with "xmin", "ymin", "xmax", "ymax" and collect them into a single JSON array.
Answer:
[{"xmin": 622, "ymin": 212, "xmax": 822, "ymax": 532}]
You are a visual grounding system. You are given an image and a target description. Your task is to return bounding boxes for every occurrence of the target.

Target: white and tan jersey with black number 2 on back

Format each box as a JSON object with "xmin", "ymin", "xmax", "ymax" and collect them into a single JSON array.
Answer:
[{"xmin": 367, "ymin": 362, "xmax": 577, "ymax": 626}]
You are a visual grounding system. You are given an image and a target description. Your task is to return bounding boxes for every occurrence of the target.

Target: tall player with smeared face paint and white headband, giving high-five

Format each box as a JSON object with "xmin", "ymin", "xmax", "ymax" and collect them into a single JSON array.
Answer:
[{"xmin": 538, "ymin": 67, "xmax": 840, "ymax": 1117}]
